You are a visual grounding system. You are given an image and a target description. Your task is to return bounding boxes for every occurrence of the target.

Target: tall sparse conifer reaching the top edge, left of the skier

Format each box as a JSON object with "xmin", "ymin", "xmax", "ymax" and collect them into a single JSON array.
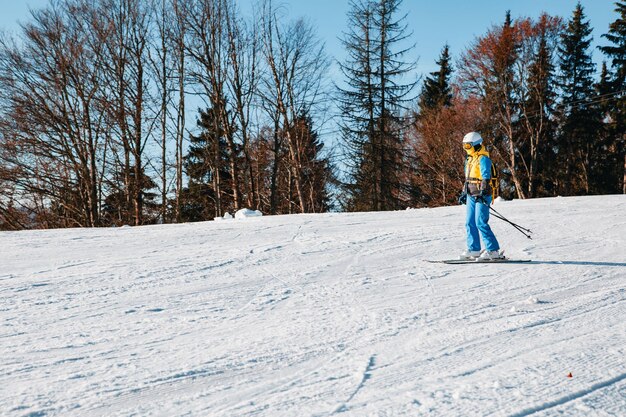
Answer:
[{"xmin": 339, "ymin": 0, "xmax": 415, "ymax": 211}]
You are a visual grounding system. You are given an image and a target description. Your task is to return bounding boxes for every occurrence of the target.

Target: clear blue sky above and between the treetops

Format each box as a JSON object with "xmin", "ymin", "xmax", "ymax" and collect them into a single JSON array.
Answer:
[{"xmin": 0, "ymin": 0, "xmax": 617, "ymax": 78}]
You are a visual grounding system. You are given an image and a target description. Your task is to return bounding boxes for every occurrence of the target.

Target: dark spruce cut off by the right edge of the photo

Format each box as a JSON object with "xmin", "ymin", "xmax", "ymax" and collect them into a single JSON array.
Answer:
[{"xmin": 600, "ymin": 1, "xmax": 626, "ymax": 194}]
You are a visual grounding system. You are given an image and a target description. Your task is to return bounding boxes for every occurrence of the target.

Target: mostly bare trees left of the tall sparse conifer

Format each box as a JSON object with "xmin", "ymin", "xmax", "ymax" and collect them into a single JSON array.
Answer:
[{"xmin": 0, "ymin": 0, "xmax": 333, "ymax": 229}]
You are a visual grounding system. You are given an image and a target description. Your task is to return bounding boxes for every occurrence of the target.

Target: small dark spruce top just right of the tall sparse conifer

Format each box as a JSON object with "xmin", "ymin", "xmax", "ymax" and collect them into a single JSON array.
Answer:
[{"xmin": 419, "ymin": 45, "xmax": 452, "ymax": 114}]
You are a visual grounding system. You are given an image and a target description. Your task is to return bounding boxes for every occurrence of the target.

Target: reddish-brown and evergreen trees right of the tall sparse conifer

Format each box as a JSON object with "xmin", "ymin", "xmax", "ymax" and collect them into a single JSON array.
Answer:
[{"xmin": 404, "ymin": 2, "xmax": 626, "ymax": 205}]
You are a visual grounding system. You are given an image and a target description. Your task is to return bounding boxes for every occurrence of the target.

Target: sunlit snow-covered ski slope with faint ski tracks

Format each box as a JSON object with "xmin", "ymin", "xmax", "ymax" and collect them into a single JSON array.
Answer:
[{"xmin": 0, "ymin": 196, "xmax": 626, "ymax": 417}]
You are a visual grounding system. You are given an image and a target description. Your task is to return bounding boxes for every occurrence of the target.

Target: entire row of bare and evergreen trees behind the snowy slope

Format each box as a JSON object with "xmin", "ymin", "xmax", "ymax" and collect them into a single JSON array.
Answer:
[{"xmin": 0, "ymin": 0, "xmax": 626, "ymax": 230}]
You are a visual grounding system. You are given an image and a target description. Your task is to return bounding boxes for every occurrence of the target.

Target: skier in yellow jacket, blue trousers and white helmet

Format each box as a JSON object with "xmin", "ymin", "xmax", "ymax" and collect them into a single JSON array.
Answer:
[{"xmin": 459, "ymin": 132, "xmax": 504, "ymax": 261}]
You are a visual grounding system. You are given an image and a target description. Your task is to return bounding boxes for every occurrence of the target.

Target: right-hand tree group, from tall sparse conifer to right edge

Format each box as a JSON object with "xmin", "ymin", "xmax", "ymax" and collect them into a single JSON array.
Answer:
[{"xmin": 340, "ymin": 0, "xmax": 626, "ymax": 210}]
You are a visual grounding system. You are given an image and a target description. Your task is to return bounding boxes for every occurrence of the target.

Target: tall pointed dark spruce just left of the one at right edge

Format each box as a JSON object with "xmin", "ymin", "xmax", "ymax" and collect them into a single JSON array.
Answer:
[{"xmin": 557, "ymin": 3, "xmax": 600, "ymax": 195}]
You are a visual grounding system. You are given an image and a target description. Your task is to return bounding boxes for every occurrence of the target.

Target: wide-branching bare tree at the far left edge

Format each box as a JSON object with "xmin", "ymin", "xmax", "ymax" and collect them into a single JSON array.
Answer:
[{"xmin": 0, "ymin": 0, "xmax": 108, "ymax": 226}]
